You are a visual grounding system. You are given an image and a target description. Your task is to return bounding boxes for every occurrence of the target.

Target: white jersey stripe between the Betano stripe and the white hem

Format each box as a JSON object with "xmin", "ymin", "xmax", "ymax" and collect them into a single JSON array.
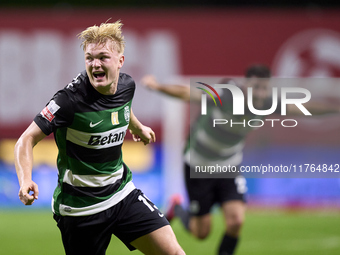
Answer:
[{"xmin": 63, "ymin": 166, "xmax": 124, "ymax": 187}]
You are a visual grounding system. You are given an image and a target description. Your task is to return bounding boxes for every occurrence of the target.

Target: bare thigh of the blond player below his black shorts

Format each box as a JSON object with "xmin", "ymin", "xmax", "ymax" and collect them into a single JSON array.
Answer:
[{"xmin": 131, "ymin": 225, "xmax": 185, "ymax": 255}]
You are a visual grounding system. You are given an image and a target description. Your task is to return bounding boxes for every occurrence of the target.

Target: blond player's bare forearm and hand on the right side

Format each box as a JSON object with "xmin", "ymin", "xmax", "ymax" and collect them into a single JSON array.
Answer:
[{"xmin": 128, "ymin": 109, "xmax": 156, "ymax": 145}]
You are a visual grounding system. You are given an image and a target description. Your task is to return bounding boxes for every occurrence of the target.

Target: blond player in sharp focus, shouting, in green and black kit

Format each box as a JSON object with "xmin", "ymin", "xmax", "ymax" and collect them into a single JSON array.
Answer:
[{"xmin": 15, "ymin": 21, "xmax": 184, "ymax": 255}]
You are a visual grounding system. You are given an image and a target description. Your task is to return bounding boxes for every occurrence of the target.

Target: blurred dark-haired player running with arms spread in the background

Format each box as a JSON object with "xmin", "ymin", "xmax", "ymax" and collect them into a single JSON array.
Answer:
[{"xmin": 141, "ymin": 65, "xmax": 339, "ymax": 255}]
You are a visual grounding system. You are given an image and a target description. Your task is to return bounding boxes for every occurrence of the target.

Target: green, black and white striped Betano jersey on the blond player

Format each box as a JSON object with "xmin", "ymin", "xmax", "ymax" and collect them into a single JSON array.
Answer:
[{"xmin": 34, "ymin": 71, "xmax": 135, "ymax": 216}]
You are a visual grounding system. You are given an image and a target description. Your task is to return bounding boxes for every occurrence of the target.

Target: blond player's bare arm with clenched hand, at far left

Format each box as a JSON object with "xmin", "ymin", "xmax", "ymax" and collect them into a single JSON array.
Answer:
[{"xmin": 14, "ymin": 122, "xmax": 46, "ymax": 205}]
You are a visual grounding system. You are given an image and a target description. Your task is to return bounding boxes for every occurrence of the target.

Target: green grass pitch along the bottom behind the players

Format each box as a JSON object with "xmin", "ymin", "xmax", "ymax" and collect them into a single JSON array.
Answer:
[{"xmin": 0, "ymin": 209, "xmax": 340, "ymax": 255}]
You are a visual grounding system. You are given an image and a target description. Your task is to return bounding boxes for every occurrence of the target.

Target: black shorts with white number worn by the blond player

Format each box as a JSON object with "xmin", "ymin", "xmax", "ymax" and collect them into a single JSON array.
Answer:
[{"xmin": 54, "ymin": 189, "xmax": 169, "ymax": 255}]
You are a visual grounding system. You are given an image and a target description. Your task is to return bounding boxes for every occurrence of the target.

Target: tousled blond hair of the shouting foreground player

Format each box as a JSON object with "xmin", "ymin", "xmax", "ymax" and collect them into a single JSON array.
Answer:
[{"xmin": 78, "ymin": 20, "xmax": 125, "ymax": 54}]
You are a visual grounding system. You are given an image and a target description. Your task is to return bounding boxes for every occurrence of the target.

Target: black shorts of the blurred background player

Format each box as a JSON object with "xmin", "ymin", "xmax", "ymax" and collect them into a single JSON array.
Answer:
[{"xmin": 184, "ymin": 164, "xmax": 247, "ymax": 216}]
